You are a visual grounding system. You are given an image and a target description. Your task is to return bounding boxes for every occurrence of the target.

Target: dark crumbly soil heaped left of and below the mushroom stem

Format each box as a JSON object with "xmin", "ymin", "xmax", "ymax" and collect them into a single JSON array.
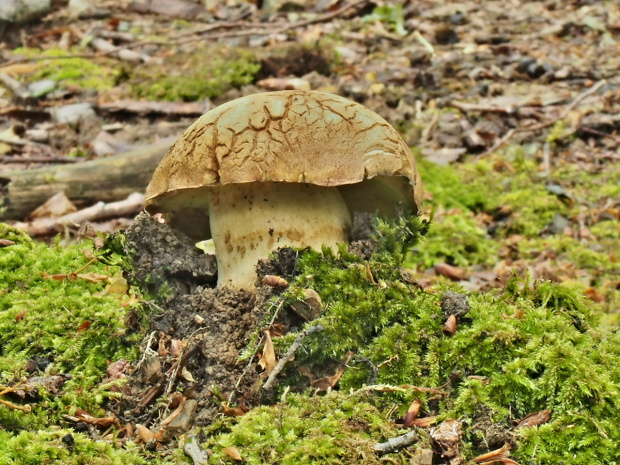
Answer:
[{"xmin": 113, "ymin": 214, "xmax": 272, "ymax": 434}]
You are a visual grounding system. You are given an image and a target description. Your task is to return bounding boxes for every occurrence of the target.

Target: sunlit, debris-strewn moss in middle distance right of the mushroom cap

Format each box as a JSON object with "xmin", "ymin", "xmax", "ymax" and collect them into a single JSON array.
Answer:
[{"xmin": 406, "ymin": 150, "xmax": 620, "ymax": 322}]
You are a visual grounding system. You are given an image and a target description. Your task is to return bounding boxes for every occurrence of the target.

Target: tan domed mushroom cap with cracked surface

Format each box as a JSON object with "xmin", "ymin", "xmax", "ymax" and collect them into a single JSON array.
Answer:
[{"xmin": 145, "ymin": 90, "xmax": 423, "ymax": 236}]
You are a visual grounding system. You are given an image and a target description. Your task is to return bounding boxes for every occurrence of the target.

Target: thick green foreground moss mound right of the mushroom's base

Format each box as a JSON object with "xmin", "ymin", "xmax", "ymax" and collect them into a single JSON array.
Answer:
[{"xmin": 228, "ymin": 216, "xmax": 620, "ymax": 465}]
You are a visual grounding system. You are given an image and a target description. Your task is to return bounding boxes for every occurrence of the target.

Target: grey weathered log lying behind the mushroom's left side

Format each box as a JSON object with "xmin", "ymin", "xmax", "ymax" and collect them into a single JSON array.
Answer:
[{"xmin": 0, "ymin": 138, "xmax": 173, "ymax": 221}]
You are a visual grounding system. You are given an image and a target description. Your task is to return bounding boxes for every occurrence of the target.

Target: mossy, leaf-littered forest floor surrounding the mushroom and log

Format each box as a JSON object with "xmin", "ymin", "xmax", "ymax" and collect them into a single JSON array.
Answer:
[{"xmin": 0, "ymin": 0, "xmax": 620, "ymax": 464}]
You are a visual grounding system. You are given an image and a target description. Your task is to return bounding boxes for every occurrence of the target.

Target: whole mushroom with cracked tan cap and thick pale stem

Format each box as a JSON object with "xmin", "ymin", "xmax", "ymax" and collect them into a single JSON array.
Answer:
[{"xmin": 145, "ymin": 91, "xmax": 422, "ymax": 289}]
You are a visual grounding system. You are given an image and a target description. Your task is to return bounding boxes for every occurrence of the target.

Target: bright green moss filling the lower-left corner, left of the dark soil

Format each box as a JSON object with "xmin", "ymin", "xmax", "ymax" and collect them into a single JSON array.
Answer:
[{"xmin": 0, "ymin": 225, "xmax": 177, "ymax": 465}]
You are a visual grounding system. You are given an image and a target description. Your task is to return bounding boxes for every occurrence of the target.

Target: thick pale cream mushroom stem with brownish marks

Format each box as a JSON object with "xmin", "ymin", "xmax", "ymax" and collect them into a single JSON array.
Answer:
[{"xmin": 209, "ymin": 182, "xmax": 351, "ymax": 289}]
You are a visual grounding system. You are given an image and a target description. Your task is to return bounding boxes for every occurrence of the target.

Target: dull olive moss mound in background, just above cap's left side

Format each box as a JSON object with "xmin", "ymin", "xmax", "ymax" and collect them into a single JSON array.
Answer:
[{"xmin": 130, "ymin": 48, "xmax": 260, "ymax": 101}]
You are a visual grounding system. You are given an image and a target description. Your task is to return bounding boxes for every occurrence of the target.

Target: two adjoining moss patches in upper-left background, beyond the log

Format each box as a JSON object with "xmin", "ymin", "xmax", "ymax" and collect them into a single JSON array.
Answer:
[{"xmin": 11, "ymin": 46, "xmax": 261, "ymax": 101}]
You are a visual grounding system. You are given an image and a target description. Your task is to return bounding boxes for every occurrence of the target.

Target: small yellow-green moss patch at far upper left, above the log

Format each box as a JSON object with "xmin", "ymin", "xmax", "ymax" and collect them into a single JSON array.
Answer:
[{"xmin": 11, "ymin": 47, "xmax": 117, "ymax": 90}]
